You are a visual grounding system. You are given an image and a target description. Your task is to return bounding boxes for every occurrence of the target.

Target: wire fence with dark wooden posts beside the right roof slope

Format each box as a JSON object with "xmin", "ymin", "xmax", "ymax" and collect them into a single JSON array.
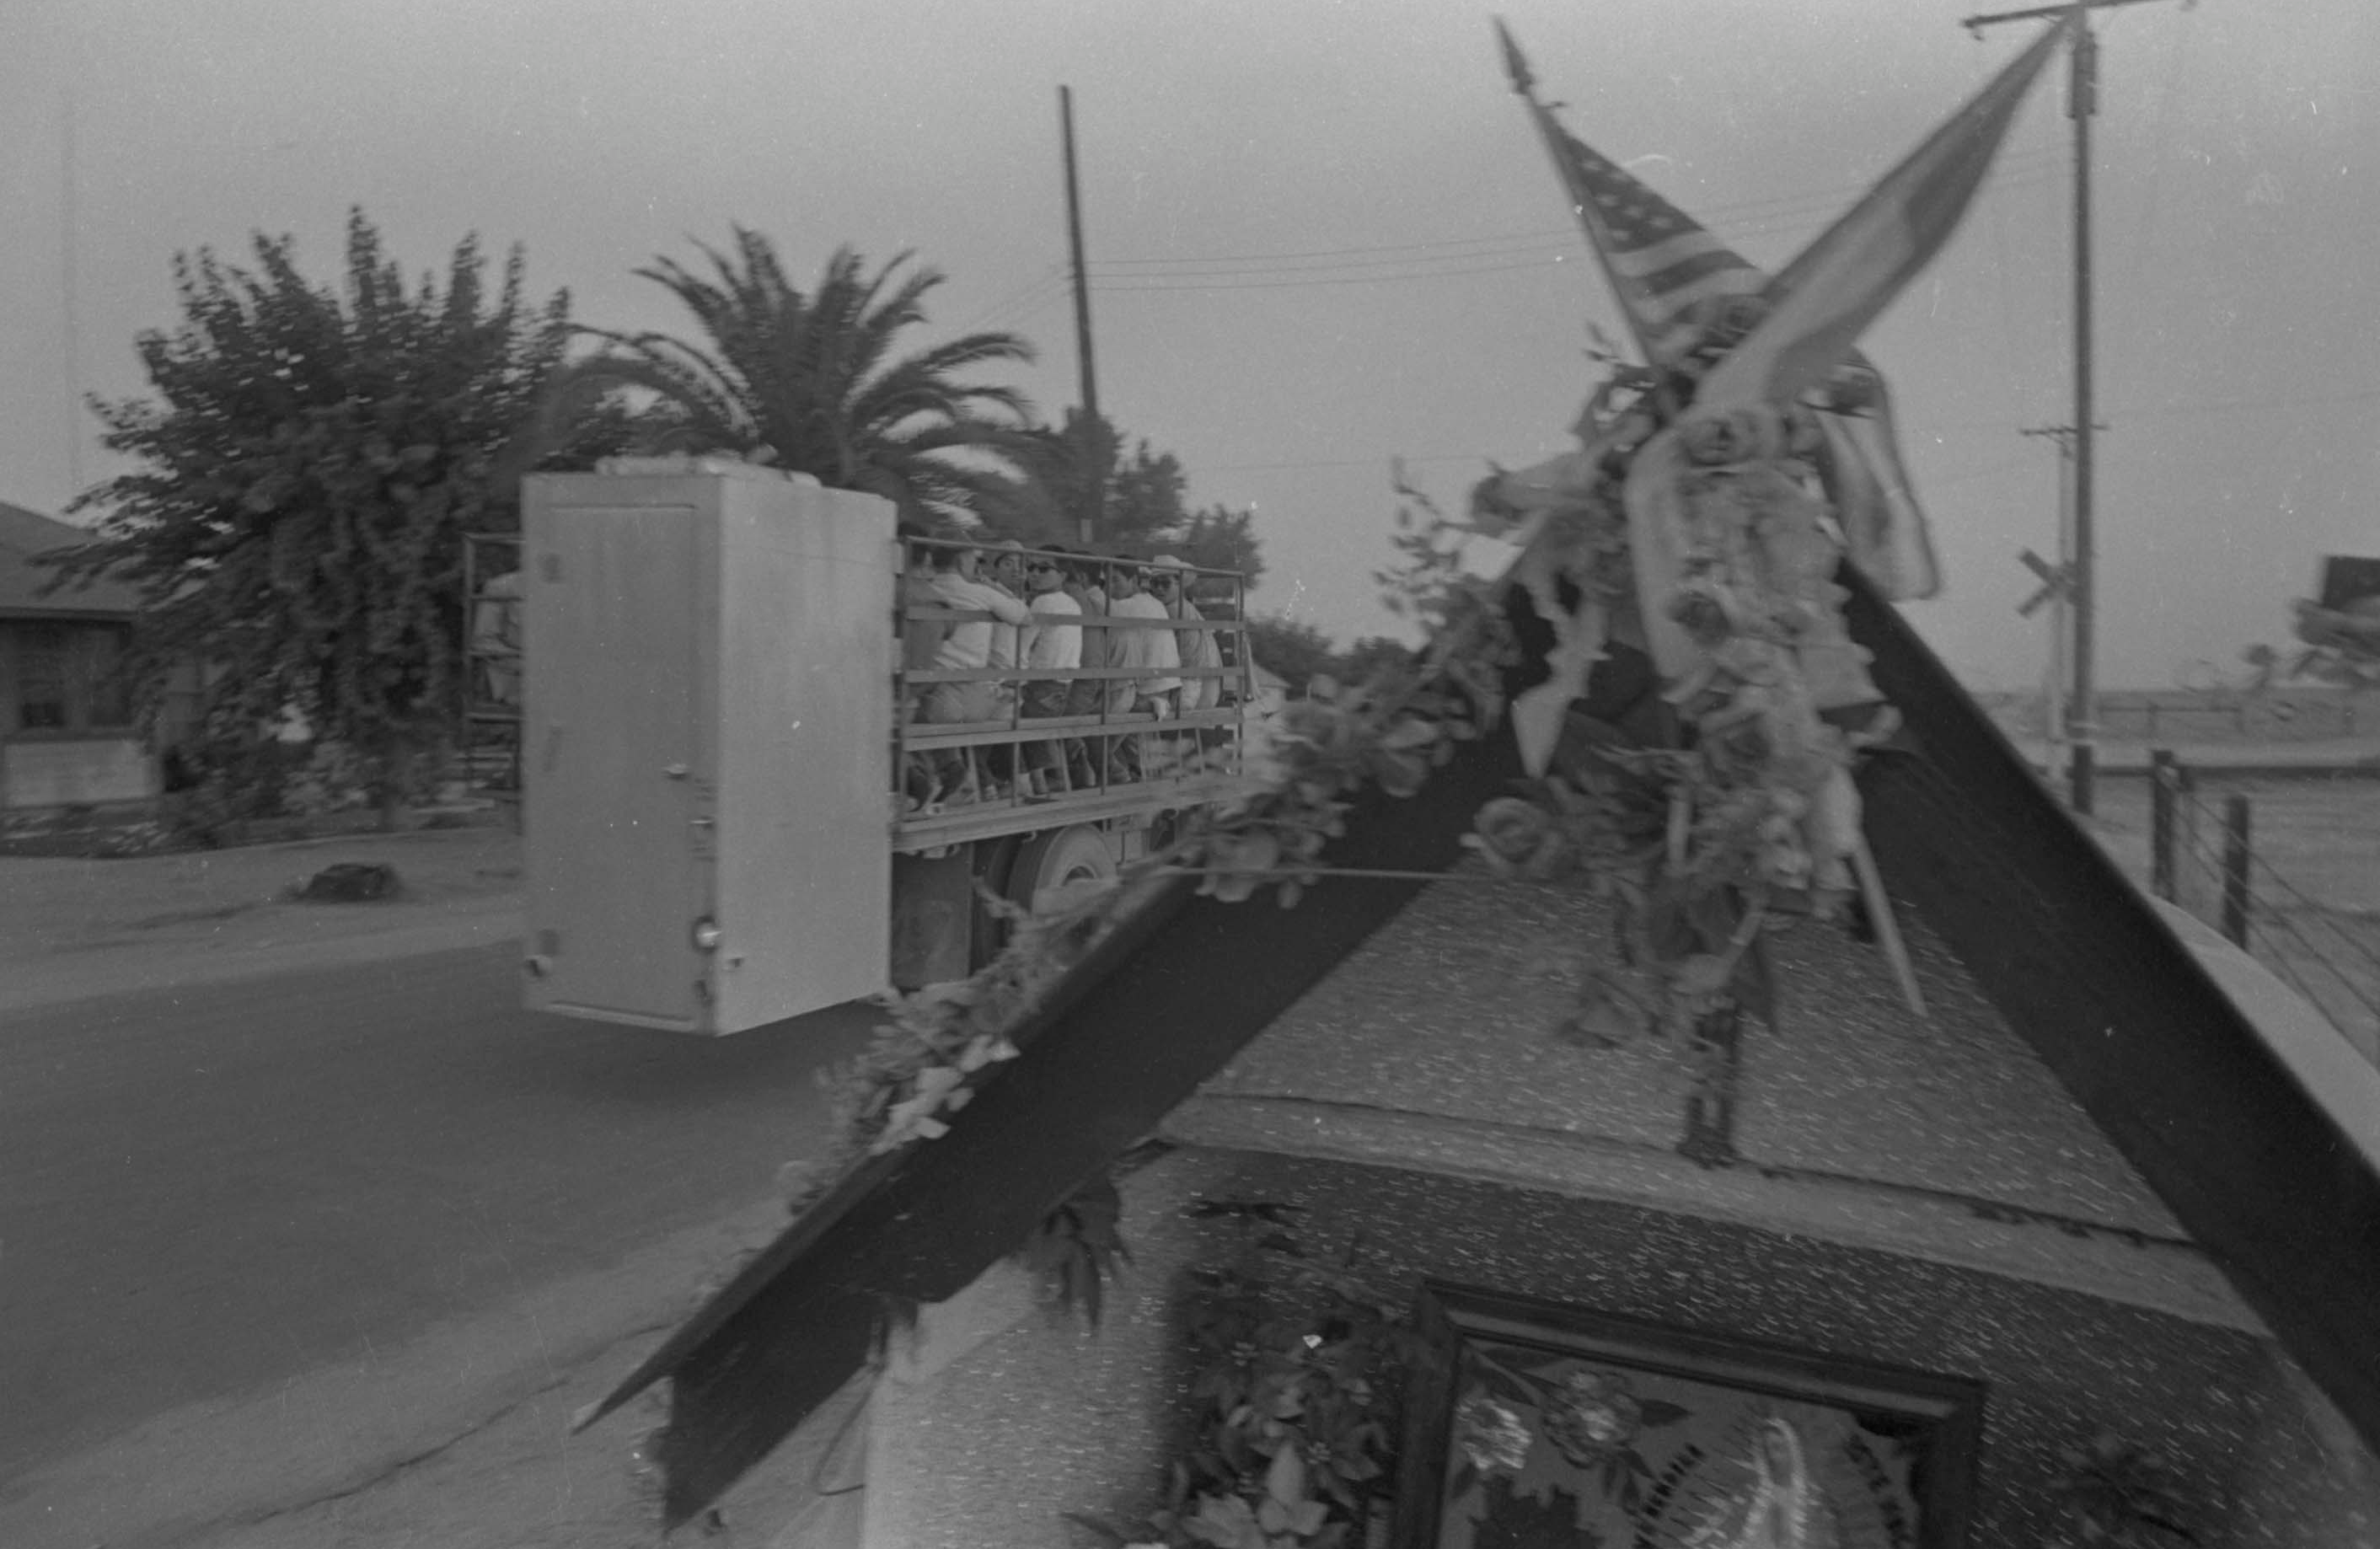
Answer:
[{"xmin": 2149, "ymin": 759, "xmax": 2380, "ymax": 1064}]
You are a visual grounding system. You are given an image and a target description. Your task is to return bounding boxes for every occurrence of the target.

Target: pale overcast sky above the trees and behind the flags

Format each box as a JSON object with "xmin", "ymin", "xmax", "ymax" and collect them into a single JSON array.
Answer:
[{"xmin": 0, "ymin": 0, "xmax": 2380, "ymax": 688}]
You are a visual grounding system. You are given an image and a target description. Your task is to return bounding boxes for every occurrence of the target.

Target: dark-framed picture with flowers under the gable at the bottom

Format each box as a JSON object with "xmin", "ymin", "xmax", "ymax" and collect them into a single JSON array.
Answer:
[{"xmin": 1392, "ymin": 1283, "xmax": 1985, "ymax": 1549}]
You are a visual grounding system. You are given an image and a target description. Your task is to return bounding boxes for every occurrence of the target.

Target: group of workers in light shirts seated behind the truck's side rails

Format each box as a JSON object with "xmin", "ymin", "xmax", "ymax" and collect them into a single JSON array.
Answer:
[{"xmin": 899, "ymin": 523, "xmax": 1245, "ymax": 809}]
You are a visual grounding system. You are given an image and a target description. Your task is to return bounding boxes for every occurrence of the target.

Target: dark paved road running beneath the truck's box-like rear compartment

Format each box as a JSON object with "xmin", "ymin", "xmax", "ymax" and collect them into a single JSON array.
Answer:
[{"xmin": 0, "ymin": 942, "xmax": 873, "ymax": 1480}]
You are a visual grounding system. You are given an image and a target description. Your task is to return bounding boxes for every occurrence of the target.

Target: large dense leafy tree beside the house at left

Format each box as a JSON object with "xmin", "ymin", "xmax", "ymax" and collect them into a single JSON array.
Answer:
[{"xmin": 52, "ymin": 209, "xmax": 583, "ymax": 818}]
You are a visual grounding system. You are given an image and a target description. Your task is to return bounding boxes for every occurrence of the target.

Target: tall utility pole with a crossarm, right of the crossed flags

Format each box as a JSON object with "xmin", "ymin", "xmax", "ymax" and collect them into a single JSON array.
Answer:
[{"xmin": 1961, "ymin": 0, "xmax": 2190, "ymax": 816}]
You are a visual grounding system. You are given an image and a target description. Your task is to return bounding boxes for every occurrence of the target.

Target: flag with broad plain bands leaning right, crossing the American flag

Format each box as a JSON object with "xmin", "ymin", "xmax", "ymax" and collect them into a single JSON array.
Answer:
[{"xmin": 1695, "ymin": 12, "xmax": 2077, "ymax": 410}]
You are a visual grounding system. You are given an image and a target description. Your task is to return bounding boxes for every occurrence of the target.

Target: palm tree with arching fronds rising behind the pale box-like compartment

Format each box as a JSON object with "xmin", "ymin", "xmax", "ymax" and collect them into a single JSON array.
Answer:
[{"xmin": 574, "ymin": 226, "xmax": 1035, "ymax": 518}]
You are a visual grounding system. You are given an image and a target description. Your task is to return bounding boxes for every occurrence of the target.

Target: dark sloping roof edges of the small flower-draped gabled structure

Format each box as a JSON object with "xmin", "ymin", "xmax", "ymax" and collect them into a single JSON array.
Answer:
[{"xmin": 607, "ymin": 571, "xmax": 2380, "ymax": 1523}]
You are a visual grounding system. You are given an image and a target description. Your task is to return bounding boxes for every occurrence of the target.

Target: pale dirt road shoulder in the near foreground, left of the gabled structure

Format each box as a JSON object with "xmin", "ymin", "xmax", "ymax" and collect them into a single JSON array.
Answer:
[{"xmin": 0, "ymin": 1199, "xmax": 785, "ymax": 1549}]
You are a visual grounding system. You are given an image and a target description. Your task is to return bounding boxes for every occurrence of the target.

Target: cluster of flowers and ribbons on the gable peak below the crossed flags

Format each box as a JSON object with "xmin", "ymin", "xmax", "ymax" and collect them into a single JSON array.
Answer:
[{"xmin": 1468, "ymin": 367, "xmax": 1921, "ymax": 1044}]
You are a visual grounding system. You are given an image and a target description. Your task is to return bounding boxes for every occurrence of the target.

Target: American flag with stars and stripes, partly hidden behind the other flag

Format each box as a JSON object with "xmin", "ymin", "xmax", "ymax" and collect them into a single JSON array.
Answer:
[{"xmin": 1494, "ymin": 21, "xmax": 1942, "ymax": 602}]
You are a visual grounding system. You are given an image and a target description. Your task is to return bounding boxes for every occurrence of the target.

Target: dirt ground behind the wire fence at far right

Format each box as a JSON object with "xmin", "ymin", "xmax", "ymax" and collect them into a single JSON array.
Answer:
[{"xmin": 2088, "ymin": 771, "xmax": 2380, "ymax": 1064}]
